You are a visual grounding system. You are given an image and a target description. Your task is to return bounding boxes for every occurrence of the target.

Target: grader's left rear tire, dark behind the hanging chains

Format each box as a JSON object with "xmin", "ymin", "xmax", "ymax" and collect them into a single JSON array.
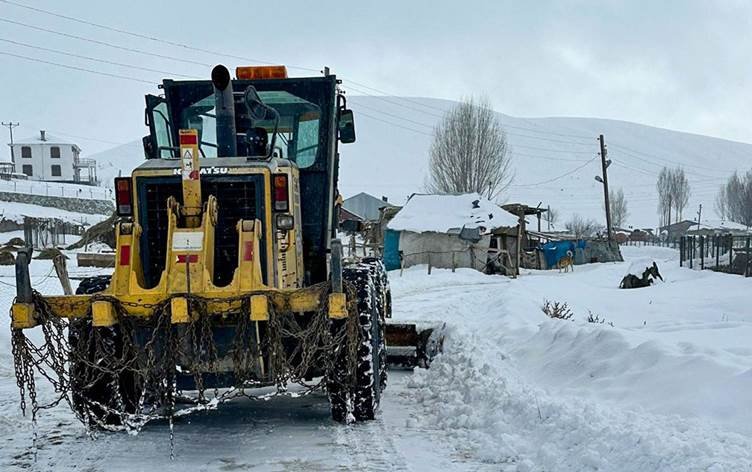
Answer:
[{"xmin": 68, "ymin": 276, "xmax": 141, "ymax": 429}]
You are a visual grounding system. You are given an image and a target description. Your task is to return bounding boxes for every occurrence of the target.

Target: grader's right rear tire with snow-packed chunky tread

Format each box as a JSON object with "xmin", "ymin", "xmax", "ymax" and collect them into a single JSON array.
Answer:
[{"xmin": 328, "ymin": 261, "xmax": 386, "ymax": 423}]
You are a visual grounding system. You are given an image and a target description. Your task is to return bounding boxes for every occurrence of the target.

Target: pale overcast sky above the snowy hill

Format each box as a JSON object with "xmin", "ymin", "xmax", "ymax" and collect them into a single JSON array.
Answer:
[{"xmin": 0, "ymin": 0, "xmax": 752, "ymax": 158}]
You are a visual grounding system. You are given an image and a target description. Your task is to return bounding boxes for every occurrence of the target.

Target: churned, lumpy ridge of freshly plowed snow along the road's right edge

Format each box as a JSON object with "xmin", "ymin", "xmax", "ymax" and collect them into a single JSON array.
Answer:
[{"xmin": 410, "ymin": 338, "xmax": 752, "ymax": 471}]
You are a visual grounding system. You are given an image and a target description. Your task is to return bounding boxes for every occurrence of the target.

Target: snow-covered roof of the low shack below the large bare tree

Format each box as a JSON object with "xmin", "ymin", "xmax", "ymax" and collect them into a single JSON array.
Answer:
[{"xmin": 387, "ymin": 193, "xmax": 517, "ymax": 233}]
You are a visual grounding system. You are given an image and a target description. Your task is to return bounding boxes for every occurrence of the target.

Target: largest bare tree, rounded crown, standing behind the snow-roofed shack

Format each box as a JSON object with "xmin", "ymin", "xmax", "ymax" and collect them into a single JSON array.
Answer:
[{"xmin": 426, "ymin": 98, "xmax": 513, "ymax": 199}]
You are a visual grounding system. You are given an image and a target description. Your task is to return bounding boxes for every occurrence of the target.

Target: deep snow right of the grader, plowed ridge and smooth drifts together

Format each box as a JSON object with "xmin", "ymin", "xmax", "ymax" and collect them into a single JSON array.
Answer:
[{"xmin": 390, "ymin": 247, "xmax": 752, "ymax": 470}]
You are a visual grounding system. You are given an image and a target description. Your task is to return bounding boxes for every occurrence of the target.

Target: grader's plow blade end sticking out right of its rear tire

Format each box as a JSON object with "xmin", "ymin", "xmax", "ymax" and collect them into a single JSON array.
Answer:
[{"xmin": 385, "ymin": 323, "xmax": 445, "ymax": 369}]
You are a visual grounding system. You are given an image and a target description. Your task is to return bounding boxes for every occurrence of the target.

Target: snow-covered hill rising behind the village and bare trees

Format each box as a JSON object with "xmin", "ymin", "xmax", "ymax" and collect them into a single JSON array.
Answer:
[{"xmin": 85, "ymin": 96, "xmax": 752, "ymax": 227}]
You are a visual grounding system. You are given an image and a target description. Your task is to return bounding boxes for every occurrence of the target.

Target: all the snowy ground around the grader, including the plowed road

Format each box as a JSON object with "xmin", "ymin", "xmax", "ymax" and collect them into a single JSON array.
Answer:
[{"xmin": 0, "ymin": 247, "xmax": 752, "ymax": 472}]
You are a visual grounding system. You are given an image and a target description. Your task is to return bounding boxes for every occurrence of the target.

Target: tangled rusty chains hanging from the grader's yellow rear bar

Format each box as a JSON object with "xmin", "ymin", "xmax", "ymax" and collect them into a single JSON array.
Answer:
[{"xmin": 12, "ymin": 283, "xmax": 359, "ymax": 443}]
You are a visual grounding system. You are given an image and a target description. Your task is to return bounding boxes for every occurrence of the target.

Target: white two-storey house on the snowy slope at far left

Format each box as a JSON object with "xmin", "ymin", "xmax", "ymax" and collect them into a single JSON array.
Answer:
[{"xmin": 12, "ymin": 130, "xmax": 97, "ymax": 184}]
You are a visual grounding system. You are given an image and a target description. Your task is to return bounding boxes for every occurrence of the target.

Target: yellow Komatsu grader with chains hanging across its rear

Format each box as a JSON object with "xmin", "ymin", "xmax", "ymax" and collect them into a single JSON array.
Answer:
[{"xmin": 11, "ymin": 65, "xmax": 438, "ymax": 429}]
